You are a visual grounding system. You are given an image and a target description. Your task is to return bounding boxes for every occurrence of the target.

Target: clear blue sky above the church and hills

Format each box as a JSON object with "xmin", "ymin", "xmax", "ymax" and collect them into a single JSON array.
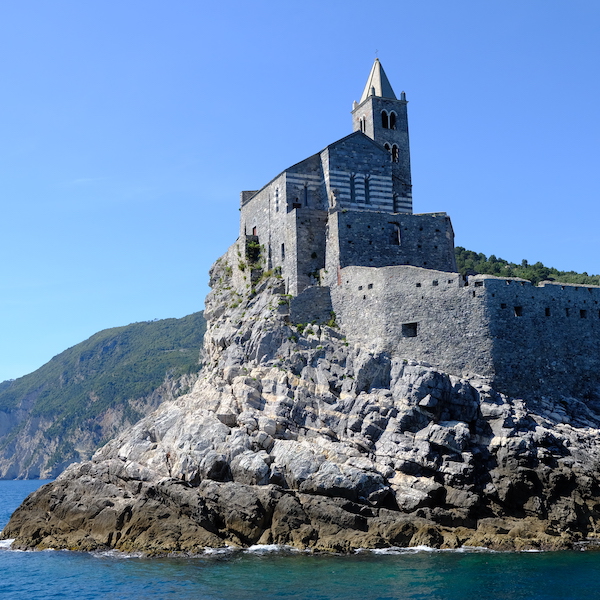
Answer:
[{"xmin": 0, "ymin": 0, "xmax": 600, "ymax": 381}]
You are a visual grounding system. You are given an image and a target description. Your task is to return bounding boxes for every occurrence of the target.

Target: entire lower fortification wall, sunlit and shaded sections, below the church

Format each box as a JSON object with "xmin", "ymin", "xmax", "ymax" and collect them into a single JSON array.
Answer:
[{"xmin": 331, "ymin": 266, "xmax": 600, "ymax": 401}]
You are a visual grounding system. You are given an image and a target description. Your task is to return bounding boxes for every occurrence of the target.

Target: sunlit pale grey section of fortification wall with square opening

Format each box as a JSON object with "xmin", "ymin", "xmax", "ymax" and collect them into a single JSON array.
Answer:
[{"xmin": 331, "ymin": 266, "xmax": 494, "ymax": 378}]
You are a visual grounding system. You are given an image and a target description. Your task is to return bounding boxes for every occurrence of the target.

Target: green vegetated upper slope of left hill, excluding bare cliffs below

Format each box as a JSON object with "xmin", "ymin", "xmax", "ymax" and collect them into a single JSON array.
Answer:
[{"xmin": 0, "ymin": 312, "xmax": 206, "ymax": 472}]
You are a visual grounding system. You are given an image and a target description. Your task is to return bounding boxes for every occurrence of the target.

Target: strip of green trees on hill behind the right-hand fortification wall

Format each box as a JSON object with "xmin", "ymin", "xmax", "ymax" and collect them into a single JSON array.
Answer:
[{"xmin": 455, "ymin": 246, "xmax": 600, "ymax": 285}]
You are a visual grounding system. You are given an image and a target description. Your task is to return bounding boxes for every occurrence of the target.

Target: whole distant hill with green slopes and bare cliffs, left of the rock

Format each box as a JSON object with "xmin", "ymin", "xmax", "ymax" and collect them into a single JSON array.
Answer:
[{"xmin": 0, "ymin": 312, "xmax": 206, "ymax": 479}]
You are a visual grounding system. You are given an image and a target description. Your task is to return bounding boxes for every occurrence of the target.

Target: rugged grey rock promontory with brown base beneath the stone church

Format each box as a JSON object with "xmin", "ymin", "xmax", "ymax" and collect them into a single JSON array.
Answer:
[{"xmin": 2, "ymin": 245, "xmax": 600, "ymax": 554}]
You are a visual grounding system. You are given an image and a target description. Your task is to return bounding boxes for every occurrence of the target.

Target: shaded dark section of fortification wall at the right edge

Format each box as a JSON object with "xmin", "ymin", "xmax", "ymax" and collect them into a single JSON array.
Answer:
[{"xmin": 476, "ymin": 276, "xmax": 600, "ymax": 400}]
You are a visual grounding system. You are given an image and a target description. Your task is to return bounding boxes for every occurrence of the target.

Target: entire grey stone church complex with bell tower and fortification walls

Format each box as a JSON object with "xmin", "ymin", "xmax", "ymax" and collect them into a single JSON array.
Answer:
[{"xmin": 240, "ymin": 61, "xmax": 600, "ymax": 400}]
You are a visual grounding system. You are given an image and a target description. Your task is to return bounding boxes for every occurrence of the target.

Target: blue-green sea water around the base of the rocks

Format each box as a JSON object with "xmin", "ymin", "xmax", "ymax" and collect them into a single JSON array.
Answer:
[{"xmin": 0, "ymin": 481, "xmax": 600, "ymax": 600}]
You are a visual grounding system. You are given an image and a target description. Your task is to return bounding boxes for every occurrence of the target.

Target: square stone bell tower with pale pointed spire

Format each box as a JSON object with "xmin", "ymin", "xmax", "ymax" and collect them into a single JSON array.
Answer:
[{"xmin": 352, "ymin": 58, "xmax": 412, "ymax": 213}]
